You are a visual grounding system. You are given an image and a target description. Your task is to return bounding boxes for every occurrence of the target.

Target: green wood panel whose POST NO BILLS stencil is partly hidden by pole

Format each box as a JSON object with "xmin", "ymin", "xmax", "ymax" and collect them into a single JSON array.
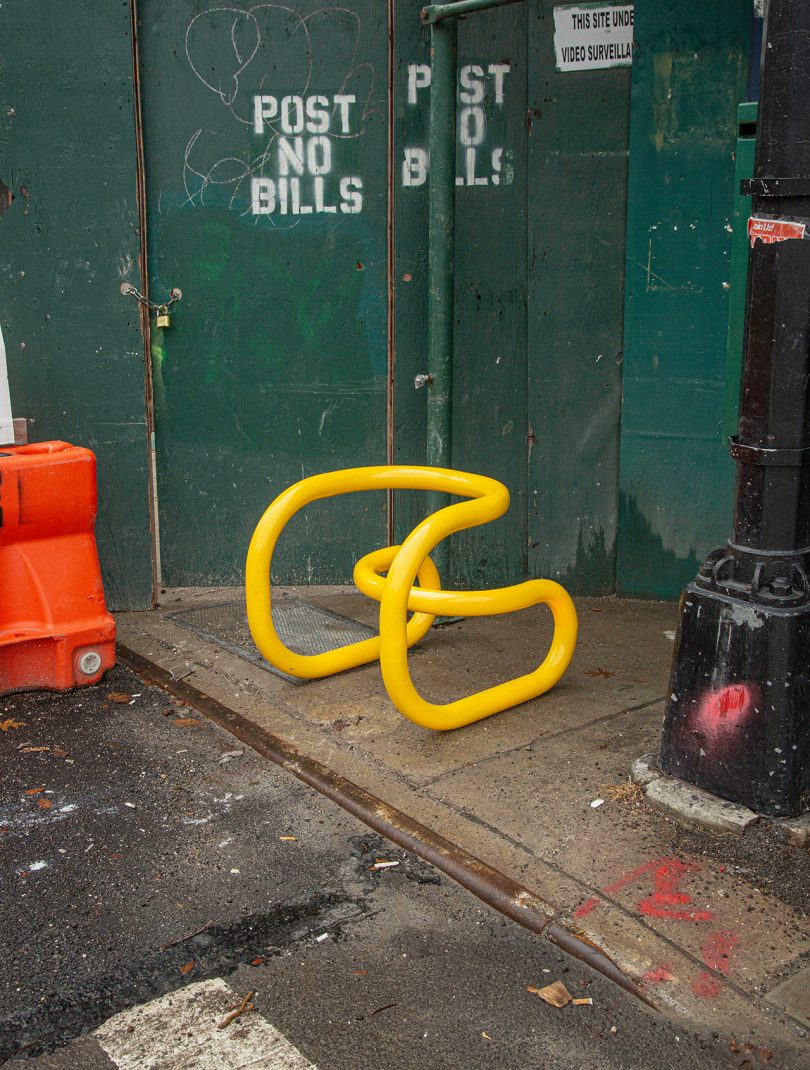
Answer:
[{"xmin": 394, "ymin": 0, "xmax": 528, "ymax": 587}]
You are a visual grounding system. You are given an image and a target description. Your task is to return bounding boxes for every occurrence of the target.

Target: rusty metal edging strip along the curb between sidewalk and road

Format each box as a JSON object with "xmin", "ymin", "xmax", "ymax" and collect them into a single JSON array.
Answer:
[{"xmin": 118, "ymin": 644, "xmax": 655, "ymax": 1008}]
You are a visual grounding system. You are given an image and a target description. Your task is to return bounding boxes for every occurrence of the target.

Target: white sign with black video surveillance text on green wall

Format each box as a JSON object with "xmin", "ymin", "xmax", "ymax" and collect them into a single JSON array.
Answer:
[{"xmin": 554, "ymin": 3, "xmax": 633, "ymax": 71}]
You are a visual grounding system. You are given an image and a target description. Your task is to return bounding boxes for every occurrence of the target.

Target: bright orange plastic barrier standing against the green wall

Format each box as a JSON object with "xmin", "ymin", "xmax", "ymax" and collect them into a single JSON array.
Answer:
[{"xmin": 0, "ymin": 442, "xmax": 116, "ymax": 694}]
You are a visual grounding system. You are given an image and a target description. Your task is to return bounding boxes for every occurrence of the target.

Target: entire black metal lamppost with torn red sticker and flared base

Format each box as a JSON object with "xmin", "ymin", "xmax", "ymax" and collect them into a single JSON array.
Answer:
[{"xmin": 660, "ymin": 0, "xmax": 810, "ymax": 816}]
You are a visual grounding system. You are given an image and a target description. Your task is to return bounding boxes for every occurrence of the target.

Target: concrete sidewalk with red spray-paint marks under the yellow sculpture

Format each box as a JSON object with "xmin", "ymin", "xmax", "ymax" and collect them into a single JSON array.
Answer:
[{"xmin": 118, "ymin": 587, "xmax": 810, "ymax": 1065}]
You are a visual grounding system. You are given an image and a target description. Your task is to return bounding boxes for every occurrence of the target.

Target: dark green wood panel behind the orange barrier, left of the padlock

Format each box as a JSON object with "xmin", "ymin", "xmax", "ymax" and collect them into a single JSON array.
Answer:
[{"xmin": 0, "ymin": 0, "xmax": 152, "ymax": 609}]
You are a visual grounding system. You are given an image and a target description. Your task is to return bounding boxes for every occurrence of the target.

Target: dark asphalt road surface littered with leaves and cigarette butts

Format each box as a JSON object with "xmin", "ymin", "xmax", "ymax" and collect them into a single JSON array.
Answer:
[{"xmin": 0, "ymin": 668, "xmax": 793, "ymax": 1070}]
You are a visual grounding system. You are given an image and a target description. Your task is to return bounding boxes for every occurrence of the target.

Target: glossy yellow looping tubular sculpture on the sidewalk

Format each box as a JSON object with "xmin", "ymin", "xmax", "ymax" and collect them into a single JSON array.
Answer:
[{"xmin": 245, "ymin": 464, "xmax": 577, "ymax": 730}]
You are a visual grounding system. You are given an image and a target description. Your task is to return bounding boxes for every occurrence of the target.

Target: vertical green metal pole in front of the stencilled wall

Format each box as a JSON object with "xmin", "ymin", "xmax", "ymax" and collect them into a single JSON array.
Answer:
[{"xmin": 427, "ymin": 18, "xmax": 458, "ymax": 472}]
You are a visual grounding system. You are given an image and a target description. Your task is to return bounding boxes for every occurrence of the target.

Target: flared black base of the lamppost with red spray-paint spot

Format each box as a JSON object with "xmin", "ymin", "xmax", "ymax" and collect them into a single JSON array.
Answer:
[{"xmin": 658, "ymin": 580, "xmax": 810, "ymax": 817}]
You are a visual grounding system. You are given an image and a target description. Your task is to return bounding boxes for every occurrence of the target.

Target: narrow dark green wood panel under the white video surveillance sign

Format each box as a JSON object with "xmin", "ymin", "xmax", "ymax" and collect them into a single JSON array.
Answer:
[{"xmin": 528, "ymin": 0, "xmax": 638, "ymax": 594}]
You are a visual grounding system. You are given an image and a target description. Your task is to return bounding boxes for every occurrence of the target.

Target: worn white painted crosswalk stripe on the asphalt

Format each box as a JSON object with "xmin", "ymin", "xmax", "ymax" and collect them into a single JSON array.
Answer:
[{"xmin": 95, "ymin": 979, "xmax": 316, "ymax": 1070}]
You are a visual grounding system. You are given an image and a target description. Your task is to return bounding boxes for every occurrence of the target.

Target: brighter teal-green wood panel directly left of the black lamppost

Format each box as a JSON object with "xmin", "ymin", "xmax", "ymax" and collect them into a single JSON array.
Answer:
[{"xmin": 617, "ymin": 0, "xmax": 752, "ymax": 597}]
